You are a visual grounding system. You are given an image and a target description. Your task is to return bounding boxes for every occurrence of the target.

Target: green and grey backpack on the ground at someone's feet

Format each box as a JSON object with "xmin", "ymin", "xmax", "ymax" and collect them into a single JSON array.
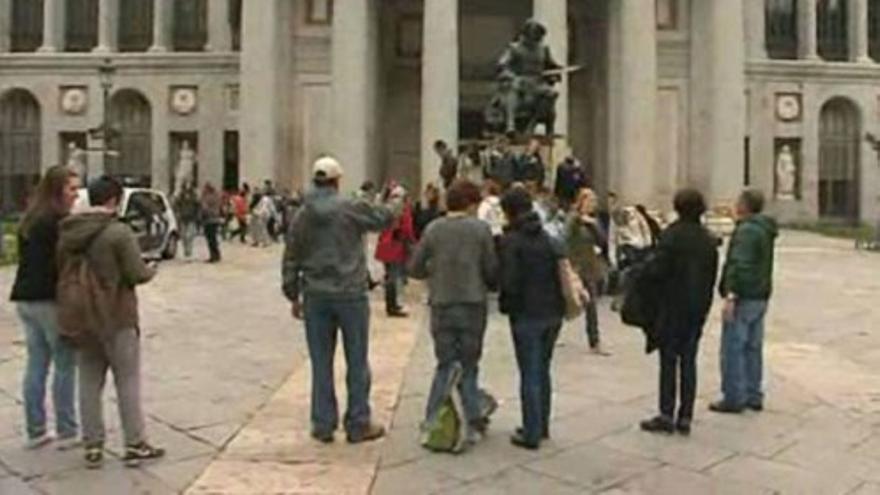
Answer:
[{"xmin": 421, "ymin": 363, "xmax": 467, "ymax": 454}]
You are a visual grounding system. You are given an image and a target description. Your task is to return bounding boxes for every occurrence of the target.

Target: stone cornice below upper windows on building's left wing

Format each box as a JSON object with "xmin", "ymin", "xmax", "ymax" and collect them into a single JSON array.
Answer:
[{"xmin": 0, "ymin": 52, "xmax": 241, "ymax": 75}]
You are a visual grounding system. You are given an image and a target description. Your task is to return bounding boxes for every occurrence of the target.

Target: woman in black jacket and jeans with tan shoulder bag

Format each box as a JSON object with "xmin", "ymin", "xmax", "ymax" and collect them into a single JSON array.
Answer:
[{"xmin": 500, "ymin": 188, "xmax": 565, "ymax": 450}]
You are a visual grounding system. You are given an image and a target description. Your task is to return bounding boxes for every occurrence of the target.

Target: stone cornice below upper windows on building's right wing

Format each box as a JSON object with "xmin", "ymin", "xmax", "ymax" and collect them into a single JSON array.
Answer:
[{"xmin": 746, "ymin": 60, "xmax": 880, "ymax": 84}]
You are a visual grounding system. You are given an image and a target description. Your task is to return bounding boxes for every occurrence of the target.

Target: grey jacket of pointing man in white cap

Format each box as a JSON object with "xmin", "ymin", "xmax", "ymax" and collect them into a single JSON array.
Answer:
[{"xmin": 282, "ymin": 187, "xmax": 395, "ymax": 301}]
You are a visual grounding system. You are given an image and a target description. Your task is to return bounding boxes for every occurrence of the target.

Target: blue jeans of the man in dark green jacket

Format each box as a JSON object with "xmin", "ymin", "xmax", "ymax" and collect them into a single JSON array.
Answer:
[{"xmin": 721, "ymin": 301, "xmax": 767, "ymax": 407}]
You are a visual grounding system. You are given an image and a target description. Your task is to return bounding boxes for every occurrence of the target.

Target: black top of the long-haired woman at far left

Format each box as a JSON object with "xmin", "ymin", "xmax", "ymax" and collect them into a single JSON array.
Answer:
[{"xmin": 10, "ymin": 214, "xmax": 61, "ymax": 302}]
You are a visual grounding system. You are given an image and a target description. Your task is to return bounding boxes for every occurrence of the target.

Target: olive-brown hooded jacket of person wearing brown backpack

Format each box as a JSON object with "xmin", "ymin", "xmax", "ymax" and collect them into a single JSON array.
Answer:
[{"xmin": 58, "ymin": 209, "xmax": 156, "ymax": 337}]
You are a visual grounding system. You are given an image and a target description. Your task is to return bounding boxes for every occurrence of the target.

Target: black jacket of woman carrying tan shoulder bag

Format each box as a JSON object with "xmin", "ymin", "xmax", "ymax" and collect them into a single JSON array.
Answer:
[{"xmin": 500, "ymin": 213, "xmax": 565, "ymax": 320}]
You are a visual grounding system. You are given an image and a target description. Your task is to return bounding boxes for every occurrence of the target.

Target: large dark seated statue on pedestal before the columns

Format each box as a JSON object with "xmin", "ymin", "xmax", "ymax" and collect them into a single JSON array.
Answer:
[{"xmin": 485, "ymin": 19, "xmax": 565, "ymax": 136}]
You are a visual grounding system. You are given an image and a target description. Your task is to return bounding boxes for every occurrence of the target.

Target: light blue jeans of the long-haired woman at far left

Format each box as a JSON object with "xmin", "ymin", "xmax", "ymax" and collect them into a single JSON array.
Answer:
[{"xmin": 16, "ymin": 302, "xmax": 79, "ymax": 439}]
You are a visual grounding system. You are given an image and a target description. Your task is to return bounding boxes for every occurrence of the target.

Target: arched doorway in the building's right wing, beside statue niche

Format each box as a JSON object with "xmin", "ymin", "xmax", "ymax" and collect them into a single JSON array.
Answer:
[{"xmin": 819, "ymin": 98, "xmax": 861, "ymax": 222}]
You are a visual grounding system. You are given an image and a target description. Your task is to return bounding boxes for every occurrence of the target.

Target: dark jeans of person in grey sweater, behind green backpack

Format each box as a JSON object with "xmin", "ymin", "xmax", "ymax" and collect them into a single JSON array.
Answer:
[{"xmin": 425, "ymin": 304, "xmax": 487, "ymax": 423}]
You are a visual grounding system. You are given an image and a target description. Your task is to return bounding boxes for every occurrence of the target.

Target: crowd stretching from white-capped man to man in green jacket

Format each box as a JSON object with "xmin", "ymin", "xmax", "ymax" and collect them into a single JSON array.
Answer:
[{"xmin": 283, "ymin": 151, "xmax": 777, "ymax": 449}]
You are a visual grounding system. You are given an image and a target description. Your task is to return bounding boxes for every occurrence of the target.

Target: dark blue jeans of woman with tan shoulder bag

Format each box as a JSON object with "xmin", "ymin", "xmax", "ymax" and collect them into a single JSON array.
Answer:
[{"xmin": 510, "ymin": 318, "xmax": 562, "ymax": 445}]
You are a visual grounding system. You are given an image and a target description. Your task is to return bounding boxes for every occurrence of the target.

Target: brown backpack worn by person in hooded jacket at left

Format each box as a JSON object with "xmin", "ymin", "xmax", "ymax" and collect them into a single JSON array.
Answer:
[{"xmin": 56, "ymin": 223, "xmax": 110, "ymax": 343}]
